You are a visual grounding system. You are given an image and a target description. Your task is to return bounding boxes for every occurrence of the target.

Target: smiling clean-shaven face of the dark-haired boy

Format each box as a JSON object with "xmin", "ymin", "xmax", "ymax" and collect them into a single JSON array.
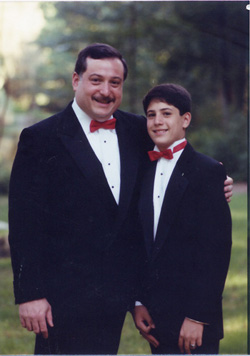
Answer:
[{"xmin": 147, "ymin": 99, "xmax": 191, "ymax": 151}]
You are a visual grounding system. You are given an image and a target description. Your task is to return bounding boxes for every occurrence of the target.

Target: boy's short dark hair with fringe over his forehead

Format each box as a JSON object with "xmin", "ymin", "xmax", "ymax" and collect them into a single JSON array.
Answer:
[{"xmin": 142, "ymin": 84, "xmax": 192, "ymax": 115}]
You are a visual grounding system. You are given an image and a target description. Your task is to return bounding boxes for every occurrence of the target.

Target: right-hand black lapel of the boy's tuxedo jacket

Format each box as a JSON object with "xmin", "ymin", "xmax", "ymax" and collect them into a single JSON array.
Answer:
[{"xmin": 152, "ymin": 144, "xmax": 193, "ymax": 259}]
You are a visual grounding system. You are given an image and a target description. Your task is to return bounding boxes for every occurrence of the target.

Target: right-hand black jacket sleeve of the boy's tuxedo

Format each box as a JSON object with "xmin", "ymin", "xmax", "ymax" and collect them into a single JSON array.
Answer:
[{"xmin": 186, "ymin": 163, "xmax": 232, "ymax": 324}]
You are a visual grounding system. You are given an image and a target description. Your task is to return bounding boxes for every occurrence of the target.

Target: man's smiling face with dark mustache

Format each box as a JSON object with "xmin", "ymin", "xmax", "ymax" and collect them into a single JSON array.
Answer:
[{"xmin": 72, "ymin": 58, "xmax": 124, "ymax": 121}]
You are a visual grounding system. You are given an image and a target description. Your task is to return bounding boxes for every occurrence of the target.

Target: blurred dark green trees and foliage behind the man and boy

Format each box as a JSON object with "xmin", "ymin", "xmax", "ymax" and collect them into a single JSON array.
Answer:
[{"xmin": 0, "ymin": 1, "xmax": 249, "ymax": 185}]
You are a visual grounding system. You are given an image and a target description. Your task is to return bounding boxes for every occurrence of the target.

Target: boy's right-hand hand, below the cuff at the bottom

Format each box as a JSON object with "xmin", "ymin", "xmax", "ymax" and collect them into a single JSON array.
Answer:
[{"xmin": 178, "ymin": 318, "xmax": 204, "ymax": 355}]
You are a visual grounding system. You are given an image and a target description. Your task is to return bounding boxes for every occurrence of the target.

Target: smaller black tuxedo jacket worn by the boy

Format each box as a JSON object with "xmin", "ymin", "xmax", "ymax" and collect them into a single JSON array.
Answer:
[{"xmin": 139, "ymin": 144, "xmax": 231, "ymax": 341}]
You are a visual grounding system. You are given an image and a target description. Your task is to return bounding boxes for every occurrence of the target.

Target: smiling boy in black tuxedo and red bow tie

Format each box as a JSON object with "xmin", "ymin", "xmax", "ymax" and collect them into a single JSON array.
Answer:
[{"xmin": 134, "ymin": 84, "xmax": 231, "ymax": 354}]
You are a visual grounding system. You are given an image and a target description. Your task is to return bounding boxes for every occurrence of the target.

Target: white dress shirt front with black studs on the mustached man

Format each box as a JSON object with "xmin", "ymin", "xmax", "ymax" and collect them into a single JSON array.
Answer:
[{"xmin": 72, "ymin": 99, "xmax": 121, "ymax": 204}]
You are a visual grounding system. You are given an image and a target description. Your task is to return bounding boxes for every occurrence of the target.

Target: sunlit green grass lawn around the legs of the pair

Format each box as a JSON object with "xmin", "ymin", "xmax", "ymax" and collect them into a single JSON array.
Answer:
[{"xmin": 0, "ymin": 194, "xmax": 247, "ymax": 355}]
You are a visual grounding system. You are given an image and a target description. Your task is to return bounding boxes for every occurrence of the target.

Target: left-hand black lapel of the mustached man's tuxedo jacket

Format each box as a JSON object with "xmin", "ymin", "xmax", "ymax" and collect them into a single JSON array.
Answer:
[{"xmin": 58, "ymin": 108, "xmax": 117, "ymax": 209}]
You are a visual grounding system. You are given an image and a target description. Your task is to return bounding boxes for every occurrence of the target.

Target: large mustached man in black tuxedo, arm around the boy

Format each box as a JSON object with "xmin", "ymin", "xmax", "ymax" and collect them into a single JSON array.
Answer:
[{"xmin": 9, "ymin": 44, "xmax": 232, "ymax": 354}]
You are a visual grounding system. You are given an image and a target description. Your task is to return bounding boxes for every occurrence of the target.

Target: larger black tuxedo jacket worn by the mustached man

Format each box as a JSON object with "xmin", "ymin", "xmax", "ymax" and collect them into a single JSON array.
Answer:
[{"xmin": 9, "ymin": 104, "xmax": 151, "ymax": 317}]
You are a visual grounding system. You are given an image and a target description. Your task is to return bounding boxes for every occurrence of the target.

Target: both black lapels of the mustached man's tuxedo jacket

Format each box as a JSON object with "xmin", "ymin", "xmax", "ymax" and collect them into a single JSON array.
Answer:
[{"xmin": 58, "ymin": 105, "xmax": 145, "ymax": 239}]
